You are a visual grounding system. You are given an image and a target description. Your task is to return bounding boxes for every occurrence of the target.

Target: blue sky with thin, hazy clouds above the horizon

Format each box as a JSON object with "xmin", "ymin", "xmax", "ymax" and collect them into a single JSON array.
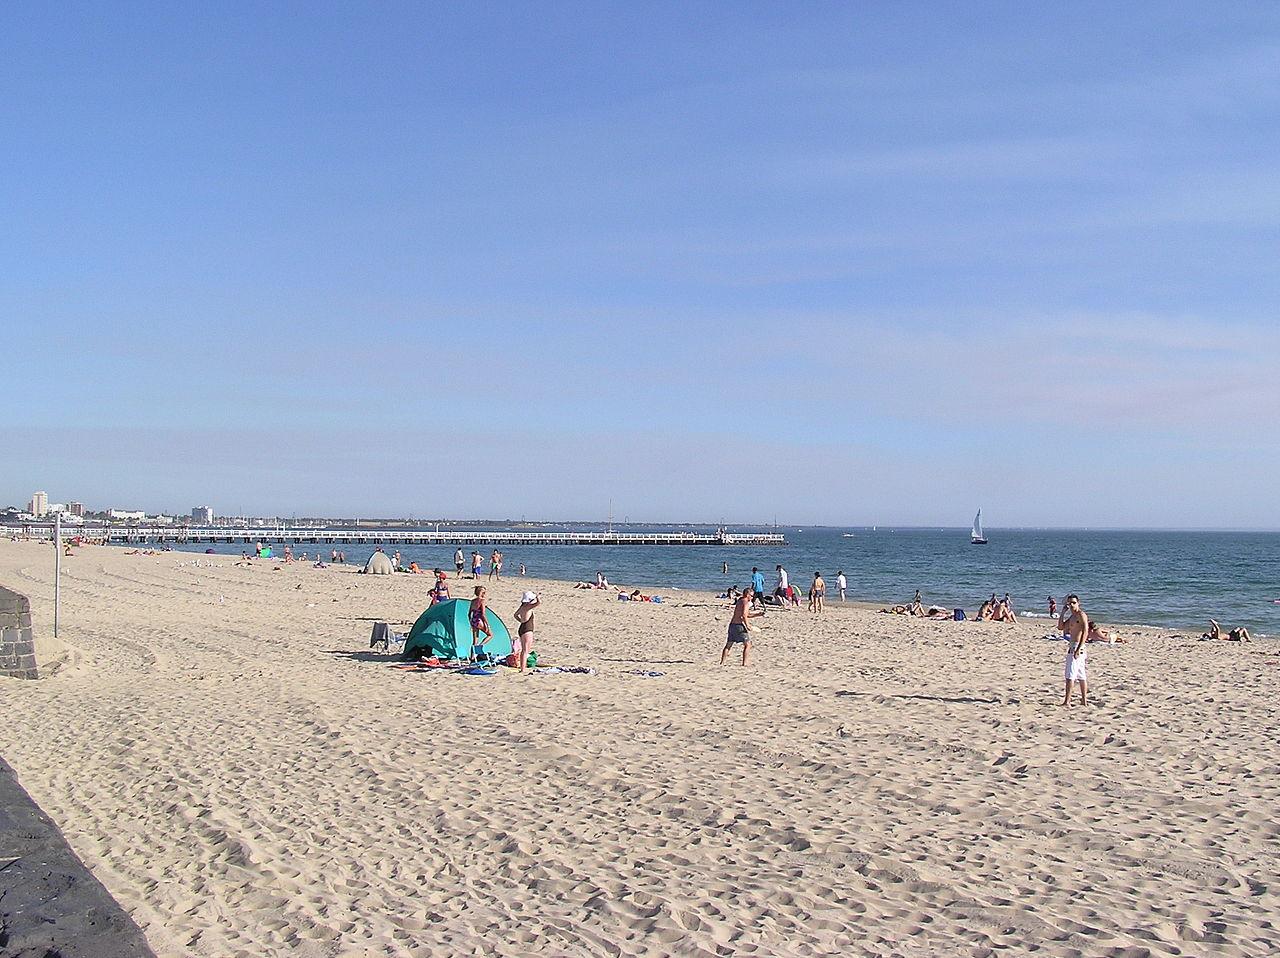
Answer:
[{"xmin": 0, "ymin": 3, "xmax": 1280, "ymax": 528}]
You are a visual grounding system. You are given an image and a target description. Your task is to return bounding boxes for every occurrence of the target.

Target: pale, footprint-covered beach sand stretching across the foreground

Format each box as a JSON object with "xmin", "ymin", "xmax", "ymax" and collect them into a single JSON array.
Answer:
[{"xmin": 0, "ymin": 542, "xmax": 1280, "ymax": 957}]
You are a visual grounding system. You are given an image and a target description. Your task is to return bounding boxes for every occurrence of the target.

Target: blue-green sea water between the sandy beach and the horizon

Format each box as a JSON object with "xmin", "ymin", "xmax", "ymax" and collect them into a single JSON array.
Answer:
[{"xmin": 154, "ymin": 526, "xmax": 1280, "ymax": 635}]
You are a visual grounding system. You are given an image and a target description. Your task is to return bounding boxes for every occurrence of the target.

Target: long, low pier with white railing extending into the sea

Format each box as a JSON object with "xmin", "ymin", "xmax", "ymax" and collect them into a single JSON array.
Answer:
[{"xmin": 12, "ymin": 525, "xmax": 787, "ymax": 546}]
